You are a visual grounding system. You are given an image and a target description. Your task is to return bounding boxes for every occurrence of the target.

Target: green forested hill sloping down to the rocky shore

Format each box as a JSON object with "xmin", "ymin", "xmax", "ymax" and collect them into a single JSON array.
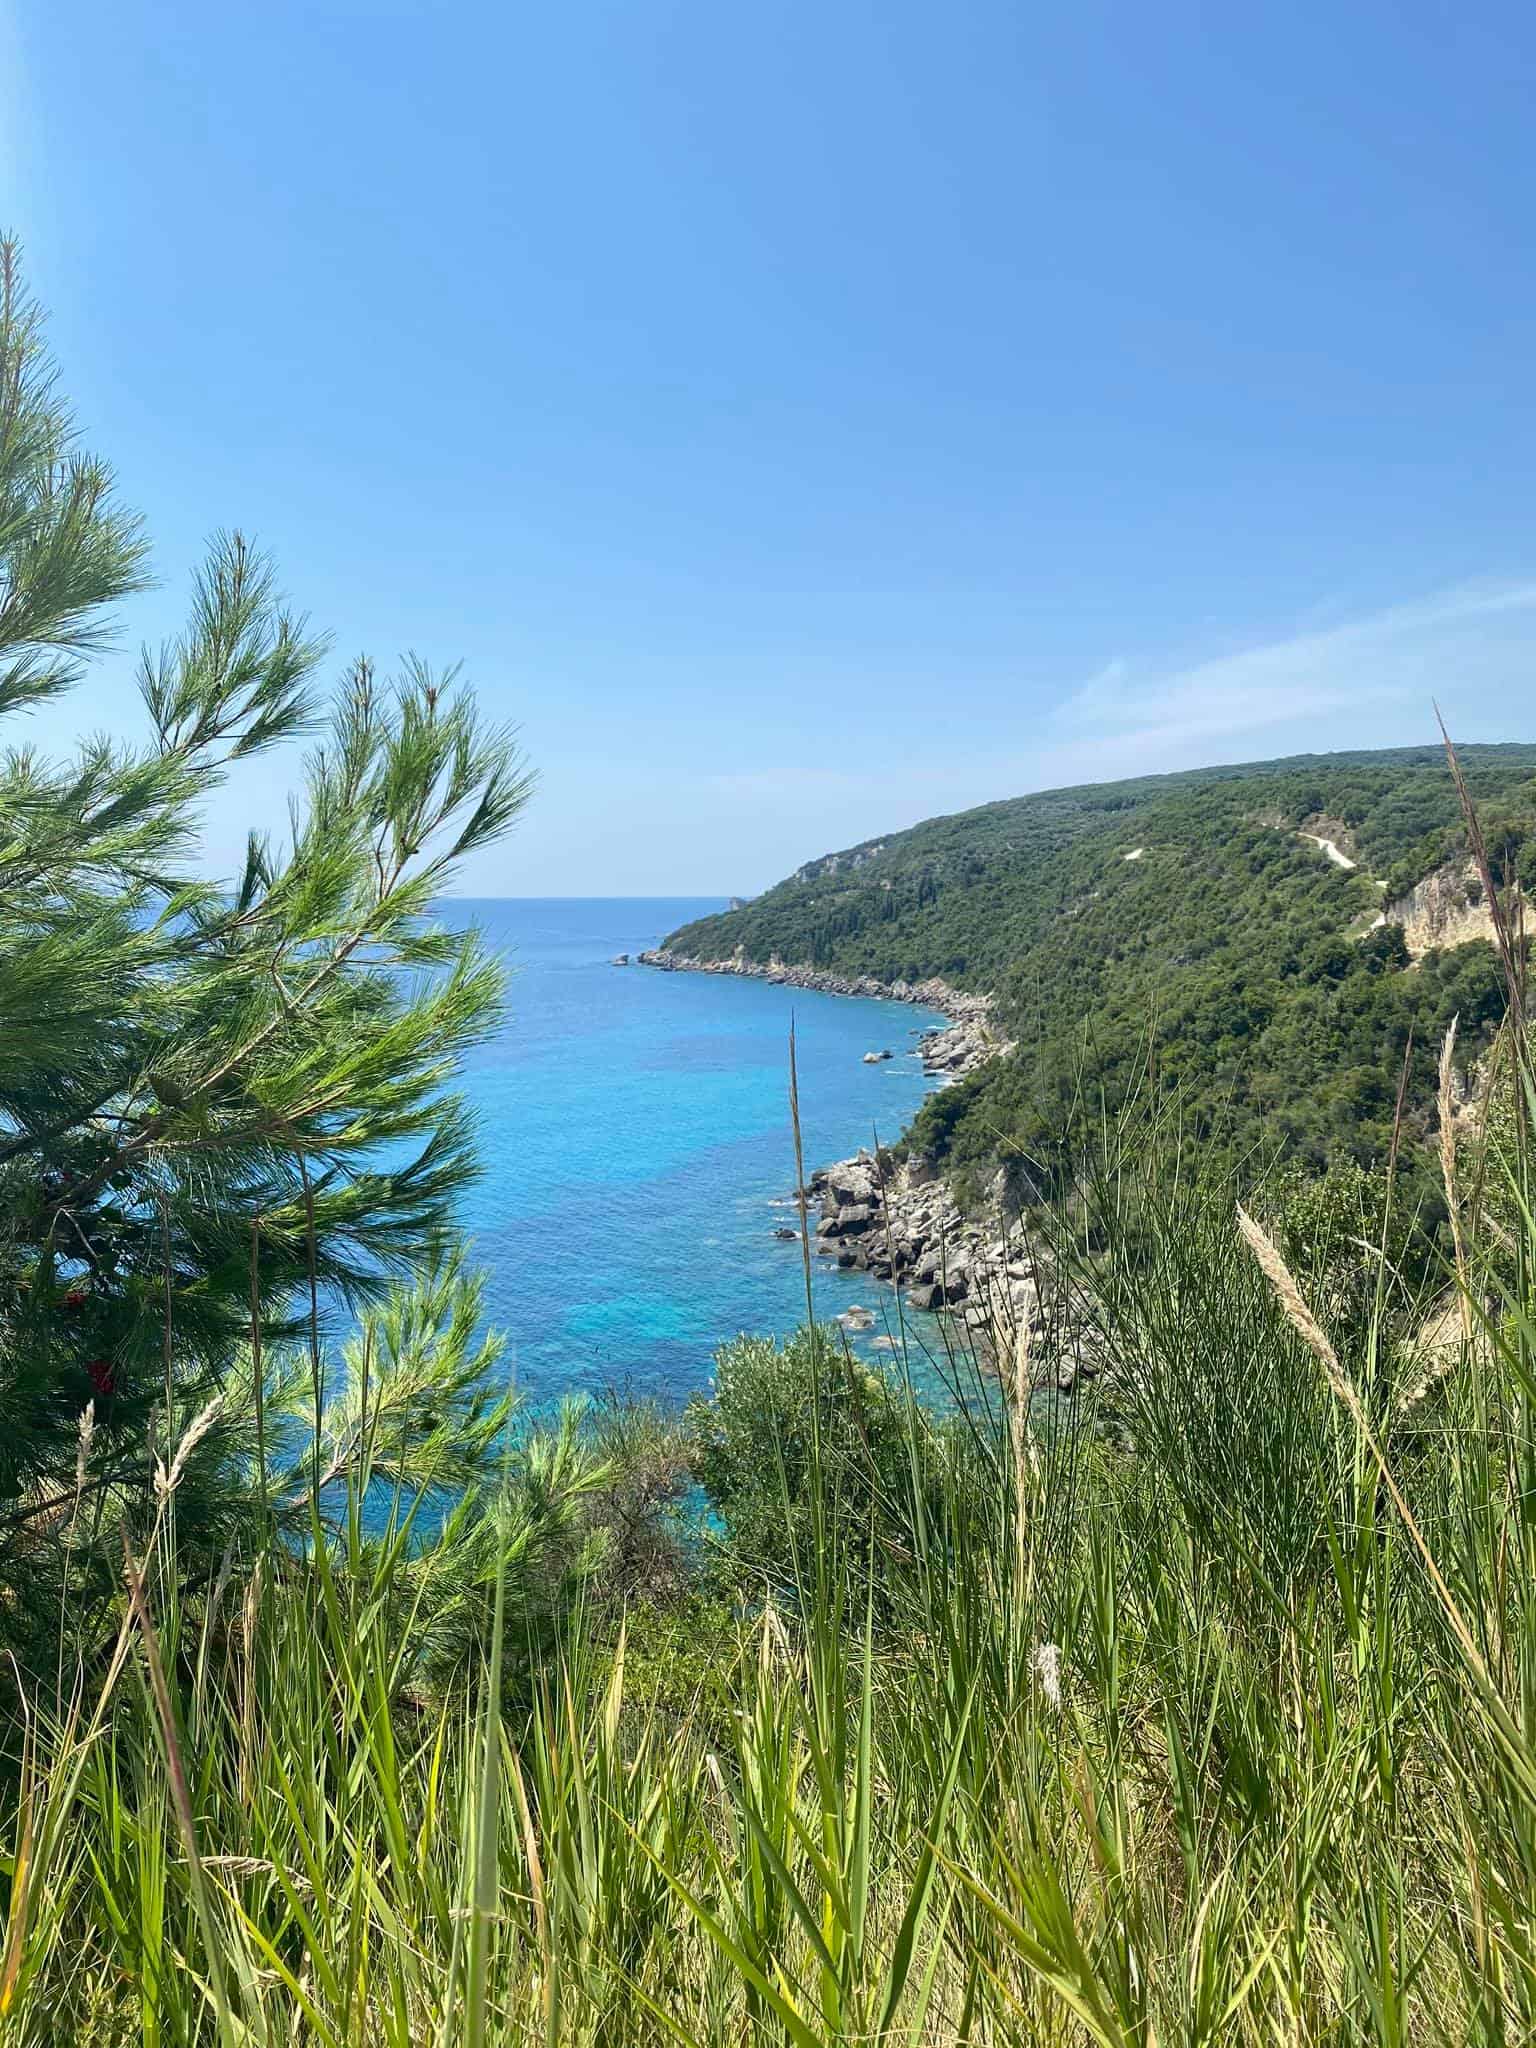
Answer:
[{"xmin": 668, "ymin": 745, "xmax": 1536, "ymax": 1178}]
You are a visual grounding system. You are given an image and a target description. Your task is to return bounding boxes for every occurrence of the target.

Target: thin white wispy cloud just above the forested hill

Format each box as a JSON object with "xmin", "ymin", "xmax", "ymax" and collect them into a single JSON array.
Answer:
[{"xmin": 1053, "ymin": 582, "xmax": 1536, "ymax": 750}]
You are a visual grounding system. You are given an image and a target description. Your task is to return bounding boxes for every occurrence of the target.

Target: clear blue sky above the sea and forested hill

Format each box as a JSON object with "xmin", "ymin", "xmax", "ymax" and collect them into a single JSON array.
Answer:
[{"xmin": 0, "ymin": 0, "xmax": 1536, "ymax": 893}]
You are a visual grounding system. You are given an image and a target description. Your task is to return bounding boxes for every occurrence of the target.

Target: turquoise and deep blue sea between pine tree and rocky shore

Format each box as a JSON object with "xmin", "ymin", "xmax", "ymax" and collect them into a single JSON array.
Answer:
[{"xmin": 444, "ymin": 897, "xmax": 942, "ymax": 1403}]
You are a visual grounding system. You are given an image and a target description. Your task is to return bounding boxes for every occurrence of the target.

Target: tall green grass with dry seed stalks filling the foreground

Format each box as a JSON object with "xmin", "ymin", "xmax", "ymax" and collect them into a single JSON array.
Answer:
[{"xmin": 0, "ymin": 1007, "xmax": 1536, "ymax": 2048}]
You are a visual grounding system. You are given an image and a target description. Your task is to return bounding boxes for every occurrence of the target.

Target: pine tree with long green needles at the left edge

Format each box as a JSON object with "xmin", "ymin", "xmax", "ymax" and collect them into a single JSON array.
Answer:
[{"xmin": 0, "ymin": 244, "xmax": 530, "ymax": 1640}]
